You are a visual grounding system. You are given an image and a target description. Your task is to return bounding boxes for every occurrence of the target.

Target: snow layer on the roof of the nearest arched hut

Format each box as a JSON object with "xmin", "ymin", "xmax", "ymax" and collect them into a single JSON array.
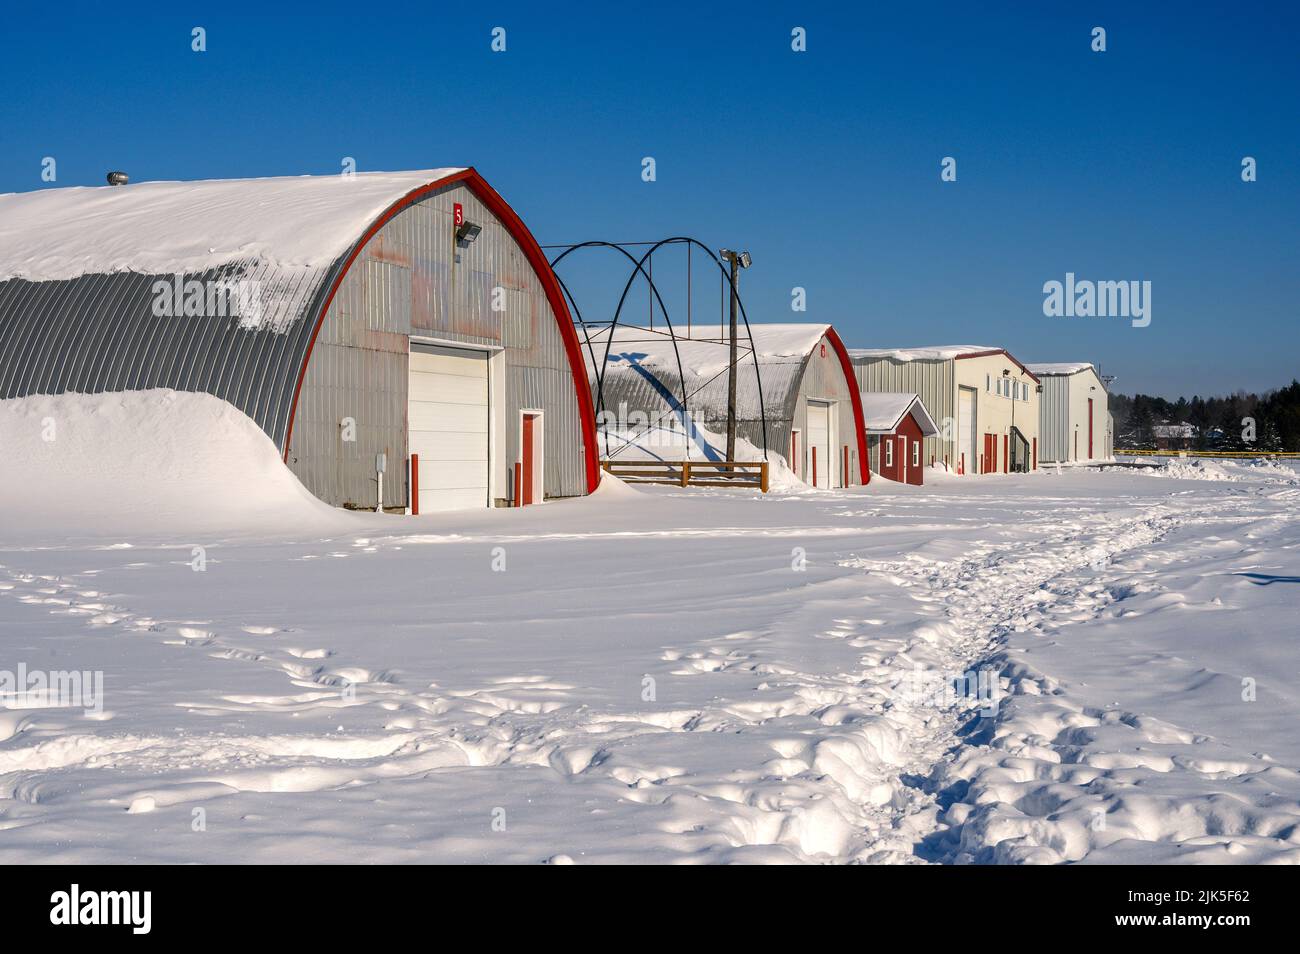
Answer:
[{"xmin": 0, "ymin": 169, "xmax": 462, "ymax": 281}]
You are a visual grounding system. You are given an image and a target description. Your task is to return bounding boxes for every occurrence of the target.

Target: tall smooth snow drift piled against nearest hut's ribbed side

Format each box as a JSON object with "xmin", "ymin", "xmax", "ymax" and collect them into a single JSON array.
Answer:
[{"xmin": 0, "ymin": 390, "xmax": 354, "ymax": 541}]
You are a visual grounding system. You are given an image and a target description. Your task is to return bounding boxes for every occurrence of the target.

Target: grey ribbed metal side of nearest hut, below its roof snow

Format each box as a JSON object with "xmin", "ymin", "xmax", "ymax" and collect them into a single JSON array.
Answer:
[{"xmin": 0, "ymin": 260, "xmax": 325, "ymax": 448}]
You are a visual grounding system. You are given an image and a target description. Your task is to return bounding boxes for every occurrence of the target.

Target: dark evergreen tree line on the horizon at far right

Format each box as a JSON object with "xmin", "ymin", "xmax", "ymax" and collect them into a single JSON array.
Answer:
[{"xmin": 1110, "ymin": 381, "xmax": 1300, "ymax": 451}]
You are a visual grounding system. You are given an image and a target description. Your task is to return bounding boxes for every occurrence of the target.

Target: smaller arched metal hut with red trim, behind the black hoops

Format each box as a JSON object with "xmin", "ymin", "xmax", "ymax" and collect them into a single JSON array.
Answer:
[{"xmin": 582, "ymin": 324, "xmax": 870, "ymax": 487}]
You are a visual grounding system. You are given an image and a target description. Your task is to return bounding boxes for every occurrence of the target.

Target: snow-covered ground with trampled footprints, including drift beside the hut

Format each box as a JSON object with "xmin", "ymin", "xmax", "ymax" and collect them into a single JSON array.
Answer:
[{"xmin": 0, "ymin": 393, "xmax": 1300, "ymax": 863}]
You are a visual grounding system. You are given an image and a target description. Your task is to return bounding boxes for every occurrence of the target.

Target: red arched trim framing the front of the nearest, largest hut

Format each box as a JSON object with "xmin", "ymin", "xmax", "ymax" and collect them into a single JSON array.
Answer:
[{"xmin": 285, "ymin": 166, "xmax": 601, "ymax": 494}]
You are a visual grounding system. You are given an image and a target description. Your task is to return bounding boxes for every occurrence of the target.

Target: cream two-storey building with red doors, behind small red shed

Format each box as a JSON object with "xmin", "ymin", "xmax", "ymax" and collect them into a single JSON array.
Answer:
[{"xmin": 849, "ymin": 344, "xmax": 1040, "ymax": 474}]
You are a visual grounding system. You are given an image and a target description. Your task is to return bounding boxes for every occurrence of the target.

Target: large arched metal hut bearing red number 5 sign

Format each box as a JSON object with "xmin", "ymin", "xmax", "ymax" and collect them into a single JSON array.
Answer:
[{"xmin": 0, "ymin": 169, "xmax": 599, "ymax": 511}]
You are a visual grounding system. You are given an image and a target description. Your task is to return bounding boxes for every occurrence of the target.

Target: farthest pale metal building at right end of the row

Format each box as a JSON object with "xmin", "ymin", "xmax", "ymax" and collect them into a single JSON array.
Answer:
[{"xmin": 1028, "ymin": 361, "xmax": 1114, "ymax": 463}]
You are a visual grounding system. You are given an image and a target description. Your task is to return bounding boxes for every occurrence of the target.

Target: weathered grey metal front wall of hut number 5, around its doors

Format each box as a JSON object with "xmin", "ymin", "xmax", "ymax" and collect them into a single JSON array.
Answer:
[{"xmin": 289, "ymin": 183, "xmax": 586, "ymax": 506}]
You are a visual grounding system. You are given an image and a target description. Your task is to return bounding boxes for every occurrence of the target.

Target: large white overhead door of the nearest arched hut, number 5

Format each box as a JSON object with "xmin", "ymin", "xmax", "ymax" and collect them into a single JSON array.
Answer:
[{"xmin": 407, "ymin": 342, "xmax": 489, "ymax": 513}]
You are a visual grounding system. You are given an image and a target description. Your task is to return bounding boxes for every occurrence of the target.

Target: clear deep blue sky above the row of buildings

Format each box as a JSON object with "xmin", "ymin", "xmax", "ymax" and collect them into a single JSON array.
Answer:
[{"xmin": 0, "ymin": 3, "xmax": 1300, "ymax": 396}]
